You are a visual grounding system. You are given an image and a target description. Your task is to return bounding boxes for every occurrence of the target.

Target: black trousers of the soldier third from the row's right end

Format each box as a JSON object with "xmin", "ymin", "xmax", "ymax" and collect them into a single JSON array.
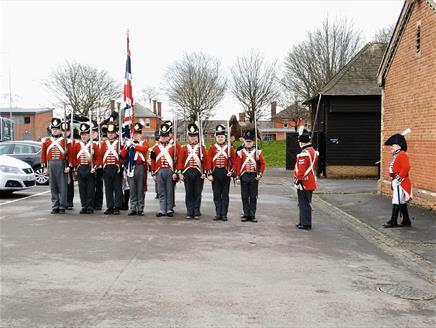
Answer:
[{"xmin": 184, "ymin": 168, "xmax": 204, "ymax": 216}]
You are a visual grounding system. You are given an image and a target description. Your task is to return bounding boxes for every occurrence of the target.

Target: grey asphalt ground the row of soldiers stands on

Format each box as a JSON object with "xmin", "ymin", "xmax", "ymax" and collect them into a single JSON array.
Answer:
[{"xmin": 0, "ymin": 172, "xmax": 436, "ymax": 327}]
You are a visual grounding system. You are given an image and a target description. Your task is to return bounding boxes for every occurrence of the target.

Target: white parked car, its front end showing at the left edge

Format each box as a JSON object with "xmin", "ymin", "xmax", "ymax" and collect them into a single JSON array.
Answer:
[{"xmin": 0, "ymin": 155, "xmax": 36, "ymax": 193}]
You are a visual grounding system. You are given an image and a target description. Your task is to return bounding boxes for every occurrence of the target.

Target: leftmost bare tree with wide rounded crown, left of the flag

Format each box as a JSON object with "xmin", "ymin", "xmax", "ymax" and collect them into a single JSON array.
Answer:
[{"xmin": 44, "ymin": 62, "xmax": 121, "ymax": 116}]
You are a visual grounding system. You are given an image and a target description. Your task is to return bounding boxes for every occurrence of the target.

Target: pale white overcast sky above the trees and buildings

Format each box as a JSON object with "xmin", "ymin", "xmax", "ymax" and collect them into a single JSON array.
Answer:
[{"xmin": 1, "ymin": 0, "xmax": 404, "ymax": 119}]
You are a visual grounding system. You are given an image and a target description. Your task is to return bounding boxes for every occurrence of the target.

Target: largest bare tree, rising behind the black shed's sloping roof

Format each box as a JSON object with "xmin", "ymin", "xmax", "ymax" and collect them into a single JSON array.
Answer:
[{"xmin": 282, "ymin": 17, "xmax": 361, "ymax": 100}]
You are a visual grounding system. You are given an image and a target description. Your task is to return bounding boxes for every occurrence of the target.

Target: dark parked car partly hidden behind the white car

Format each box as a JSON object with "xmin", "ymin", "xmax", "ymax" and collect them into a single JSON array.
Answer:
[{"xmin": 0, "ymin": 140, "xmax": 48, "ymax": 185}]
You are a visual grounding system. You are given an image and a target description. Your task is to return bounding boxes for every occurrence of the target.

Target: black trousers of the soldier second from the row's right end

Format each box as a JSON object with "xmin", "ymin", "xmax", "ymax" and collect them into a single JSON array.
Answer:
[{"xmin": 212, "ymin": 167, "xmax": 230, "ymax": 216}]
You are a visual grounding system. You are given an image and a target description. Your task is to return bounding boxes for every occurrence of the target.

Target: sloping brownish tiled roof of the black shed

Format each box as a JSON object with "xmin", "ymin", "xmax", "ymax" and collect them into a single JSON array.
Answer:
[{"xmin": 312, "ymin": 42, "xmax": 387, "ymax": 99}]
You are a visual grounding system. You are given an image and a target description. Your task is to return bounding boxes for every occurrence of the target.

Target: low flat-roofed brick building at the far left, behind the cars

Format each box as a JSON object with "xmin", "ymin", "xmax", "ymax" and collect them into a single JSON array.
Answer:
[{"xmin": 0, "ymin": 107, "xmax": 54, "ymax": 140}]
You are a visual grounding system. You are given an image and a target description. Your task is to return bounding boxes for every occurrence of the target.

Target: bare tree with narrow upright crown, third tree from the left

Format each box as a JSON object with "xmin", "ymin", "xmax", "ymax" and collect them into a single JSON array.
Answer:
[{"xmin": 231, "ymin": 50, "xmax": 277, "ymax": 122}]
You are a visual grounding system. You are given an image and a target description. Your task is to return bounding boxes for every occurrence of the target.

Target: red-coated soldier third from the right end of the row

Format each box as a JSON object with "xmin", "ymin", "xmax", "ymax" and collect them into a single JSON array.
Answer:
[{"xmin": 177, "ymin": 123, "xmax": 208, "ymax": 220}]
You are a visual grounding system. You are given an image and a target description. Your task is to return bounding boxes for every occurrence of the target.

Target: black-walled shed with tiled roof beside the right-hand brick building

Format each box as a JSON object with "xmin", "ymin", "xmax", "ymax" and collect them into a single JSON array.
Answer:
[{"xmin": 306, "ymin": 42, "xmax": 387, "ymax": 178}]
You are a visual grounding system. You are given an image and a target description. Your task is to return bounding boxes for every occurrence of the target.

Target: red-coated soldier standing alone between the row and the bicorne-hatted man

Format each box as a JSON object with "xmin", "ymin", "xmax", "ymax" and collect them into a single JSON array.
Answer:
[{"xmin": 294, "ymin": 130, "xmax": 318, "ymax": 230}]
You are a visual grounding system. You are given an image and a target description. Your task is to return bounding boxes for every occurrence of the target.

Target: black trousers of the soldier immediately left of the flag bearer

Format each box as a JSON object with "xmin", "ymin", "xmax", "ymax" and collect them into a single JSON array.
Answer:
[{"xmin": 104, "ymin": 165, "xmax": 123, "ymax": 210}]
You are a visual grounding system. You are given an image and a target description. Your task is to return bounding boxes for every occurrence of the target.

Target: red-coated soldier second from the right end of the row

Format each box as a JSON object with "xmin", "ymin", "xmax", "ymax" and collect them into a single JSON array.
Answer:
[{"xmin": 207, "ymin": 125, "xmax": 236, "ymax": 221}]
